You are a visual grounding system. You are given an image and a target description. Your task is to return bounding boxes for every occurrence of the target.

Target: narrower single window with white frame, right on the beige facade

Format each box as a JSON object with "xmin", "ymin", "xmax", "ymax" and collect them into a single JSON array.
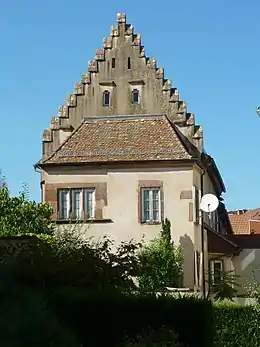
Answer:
[{"xmin": 141, "ymin": 188, "xmax": 161, "ymax": 223}]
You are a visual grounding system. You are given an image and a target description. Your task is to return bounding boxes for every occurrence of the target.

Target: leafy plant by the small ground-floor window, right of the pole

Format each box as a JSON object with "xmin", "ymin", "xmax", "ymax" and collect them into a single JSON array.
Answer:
[{"xmin": 209, "ymin": 271, "xmax": 239, "ymax": 301}]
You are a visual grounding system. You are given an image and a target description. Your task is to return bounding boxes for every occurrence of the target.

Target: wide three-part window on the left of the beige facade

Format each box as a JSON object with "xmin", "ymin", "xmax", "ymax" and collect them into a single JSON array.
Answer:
[{"xmin": 58, "ymin": 189, "xmax": 94, "ymax": 220}]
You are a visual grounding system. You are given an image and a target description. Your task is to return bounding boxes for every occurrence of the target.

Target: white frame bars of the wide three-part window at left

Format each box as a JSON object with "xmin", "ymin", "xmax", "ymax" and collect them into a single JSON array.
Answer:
[{"xmin": 58, "ymin": 188, "xmax": 95, "ymax": 220}]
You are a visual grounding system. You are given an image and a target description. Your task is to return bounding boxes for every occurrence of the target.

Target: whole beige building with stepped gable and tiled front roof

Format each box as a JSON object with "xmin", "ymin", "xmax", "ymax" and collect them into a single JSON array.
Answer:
[{"xmin": 36, "ymin": 13, "xmax": 244, "ymax": 289}]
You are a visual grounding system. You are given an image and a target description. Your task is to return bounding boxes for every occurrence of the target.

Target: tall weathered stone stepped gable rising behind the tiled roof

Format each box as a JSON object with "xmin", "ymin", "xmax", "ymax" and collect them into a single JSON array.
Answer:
[{"xmin": 42, "ymin": 13, "xmax": 203, "ymax": 160}]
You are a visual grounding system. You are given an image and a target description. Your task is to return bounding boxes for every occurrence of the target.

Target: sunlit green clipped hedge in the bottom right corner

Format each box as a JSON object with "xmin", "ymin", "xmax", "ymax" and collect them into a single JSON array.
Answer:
[{"xmin": 214, "ymin": 304, "xmax": 260, "ymax": 347}]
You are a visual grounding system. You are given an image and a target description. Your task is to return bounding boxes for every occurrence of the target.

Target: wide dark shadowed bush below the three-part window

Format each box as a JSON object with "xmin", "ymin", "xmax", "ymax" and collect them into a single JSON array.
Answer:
[{"xmin": 9, "ymin": 231, "xmax": 142, "ymax": 290}]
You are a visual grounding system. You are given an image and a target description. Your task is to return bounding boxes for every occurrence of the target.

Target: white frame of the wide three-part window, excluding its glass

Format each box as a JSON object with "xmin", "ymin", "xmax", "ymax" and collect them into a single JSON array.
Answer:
[{"xmin": 57, "ymin": 188, "xmax": 95, "ymax": 221}]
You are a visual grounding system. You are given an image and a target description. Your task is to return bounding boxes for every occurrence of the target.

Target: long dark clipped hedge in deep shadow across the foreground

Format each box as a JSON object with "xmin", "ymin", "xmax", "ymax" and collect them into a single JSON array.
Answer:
[{"xmin": 50, "ymin": 288, "xmax": 214, "ymax": 347}]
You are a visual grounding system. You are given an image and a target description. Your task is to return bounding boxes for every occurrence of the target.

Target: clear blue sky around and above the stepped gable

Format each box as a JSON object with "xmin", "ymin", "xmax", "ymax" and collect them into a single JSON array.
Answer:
[{"xmin": 0, "ymin": 0, "xmax": 260, "ymax": 209}]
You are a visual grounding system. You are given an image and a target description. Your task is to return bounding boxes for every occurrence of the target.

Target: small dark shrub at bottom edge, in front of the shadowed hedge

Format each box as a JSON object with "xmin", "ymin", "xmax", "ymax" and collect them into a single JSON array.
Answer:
[{"xmin": 118, "ymin": 326, "xmax": 184, "ymax": 347}]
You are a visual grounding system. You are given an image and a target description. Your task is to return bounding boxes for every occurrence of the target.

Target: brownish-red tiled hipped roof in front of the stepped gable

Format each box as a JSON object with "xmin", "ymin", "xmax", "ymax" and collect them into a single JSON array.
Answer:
[{"xmin": 43, "ymin": 115, "xmax": 191, "ymax": 164}]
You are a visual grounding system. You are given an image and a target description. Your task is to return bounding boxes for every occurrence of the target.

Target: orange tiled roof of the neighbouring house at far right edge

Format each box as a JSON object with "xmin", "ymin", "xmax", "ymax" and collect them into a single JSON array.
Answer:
[{"xmin": 228, "ymin": 208, "xmax": 260, "ymax": 235}]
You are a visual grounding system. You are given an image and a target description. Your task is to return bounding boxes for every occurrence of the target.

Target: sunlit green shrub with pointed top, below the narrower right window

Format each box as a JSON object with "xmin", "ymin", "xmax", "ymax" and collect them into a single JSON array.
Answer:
[{"xmin": 138, "ymin": 219, "xmax": 183, "ymax": 291}]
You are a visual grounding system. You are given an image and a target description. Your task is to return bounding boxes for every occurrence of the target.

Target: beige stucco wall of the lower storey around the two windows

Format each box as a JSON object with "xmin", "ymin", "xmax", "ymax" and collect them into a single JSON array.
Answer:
[{"xmin": 45, "ymin": 167, "xmax": 197, "ymax": 287}]
